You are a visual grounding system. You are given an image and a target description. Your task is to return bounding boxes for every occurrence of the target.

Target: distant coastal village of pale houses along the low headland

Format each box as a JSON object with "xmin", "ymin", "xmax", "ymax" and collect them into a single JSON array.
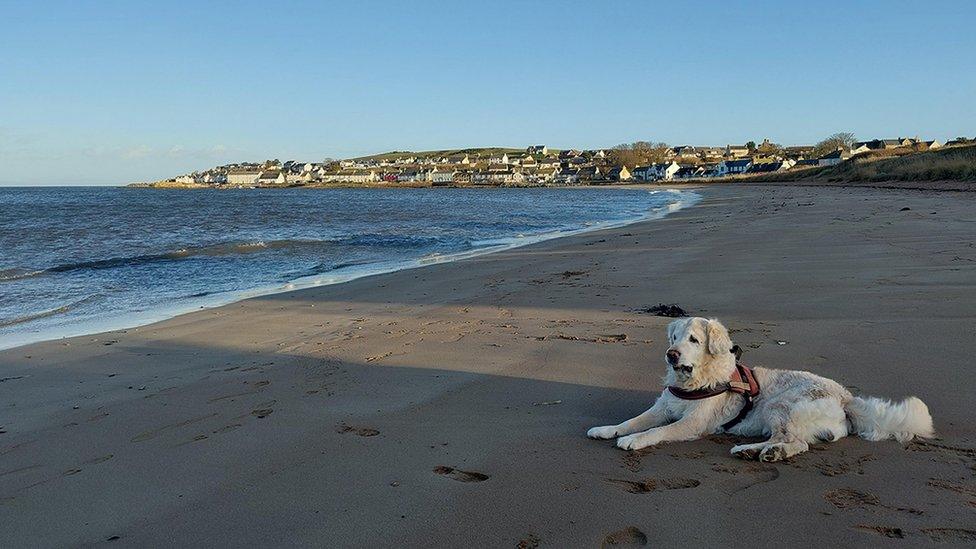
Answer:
[{"xmin": 151, "ymin": 134, "xmax": 976, "ymax": 188}]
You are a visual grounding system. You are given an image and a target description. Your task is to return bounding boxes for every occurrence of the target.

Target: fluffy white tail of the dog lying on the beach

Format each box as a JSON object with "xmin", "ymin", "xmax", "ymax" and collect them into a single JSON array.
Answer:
[{"xmin": 844, "ymin": 397, "xmax": 935, "ymax": 442}]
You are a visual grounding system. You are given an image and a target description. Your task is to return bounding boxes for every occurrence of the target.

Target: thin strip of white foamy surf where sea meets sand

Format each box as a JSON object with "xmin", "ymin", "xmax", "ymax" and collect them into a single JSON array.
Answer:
[{"xmin": 0, "ymin": 187, "xmax": 701, "ymax": 350}]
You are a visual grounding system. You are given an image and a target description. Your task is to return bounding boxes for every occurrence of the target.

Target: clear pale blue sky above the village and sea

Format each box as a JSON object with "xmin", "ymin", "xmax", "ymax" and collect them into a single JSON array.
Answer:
[{"xmin": 0, "ymin": 0, "xmax": 976, "ymax": 185}]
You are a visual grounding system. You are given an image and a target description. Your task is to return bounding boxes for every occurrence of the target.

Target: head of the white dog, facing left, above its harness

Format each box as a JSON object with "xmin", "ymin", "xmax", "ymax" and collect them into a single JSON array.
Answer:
[{"xmin": 664, "ymin": 317, "xmax": 735, "ymax": 389}]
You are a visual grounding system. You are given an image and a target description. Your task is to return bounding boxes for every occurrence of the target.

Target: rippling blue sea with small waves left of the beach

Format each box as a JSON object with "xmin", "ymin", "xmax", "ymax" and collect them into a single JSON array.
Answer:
[{"xmin": 0, "ymin": 186, "xmax": 698, "ymax": 348}]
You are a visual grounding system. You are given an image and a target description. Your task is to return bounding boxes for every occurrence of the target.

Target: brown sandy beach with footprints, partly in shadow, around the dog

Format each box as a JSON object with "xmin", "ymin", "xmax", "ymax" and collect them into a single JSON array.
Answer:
[{"xmin": 0, "ymin": 185, "xmax": 976, "ymax": 547}]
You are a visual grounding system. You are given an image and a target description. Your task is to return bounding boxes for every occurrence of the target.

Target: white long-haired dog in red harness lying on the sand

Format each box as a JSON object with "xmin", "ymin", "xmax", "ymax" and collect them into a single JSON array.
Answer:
[{"xmin": 586, "ymin": 318, "xmax": 934, "ymax": 461}]
